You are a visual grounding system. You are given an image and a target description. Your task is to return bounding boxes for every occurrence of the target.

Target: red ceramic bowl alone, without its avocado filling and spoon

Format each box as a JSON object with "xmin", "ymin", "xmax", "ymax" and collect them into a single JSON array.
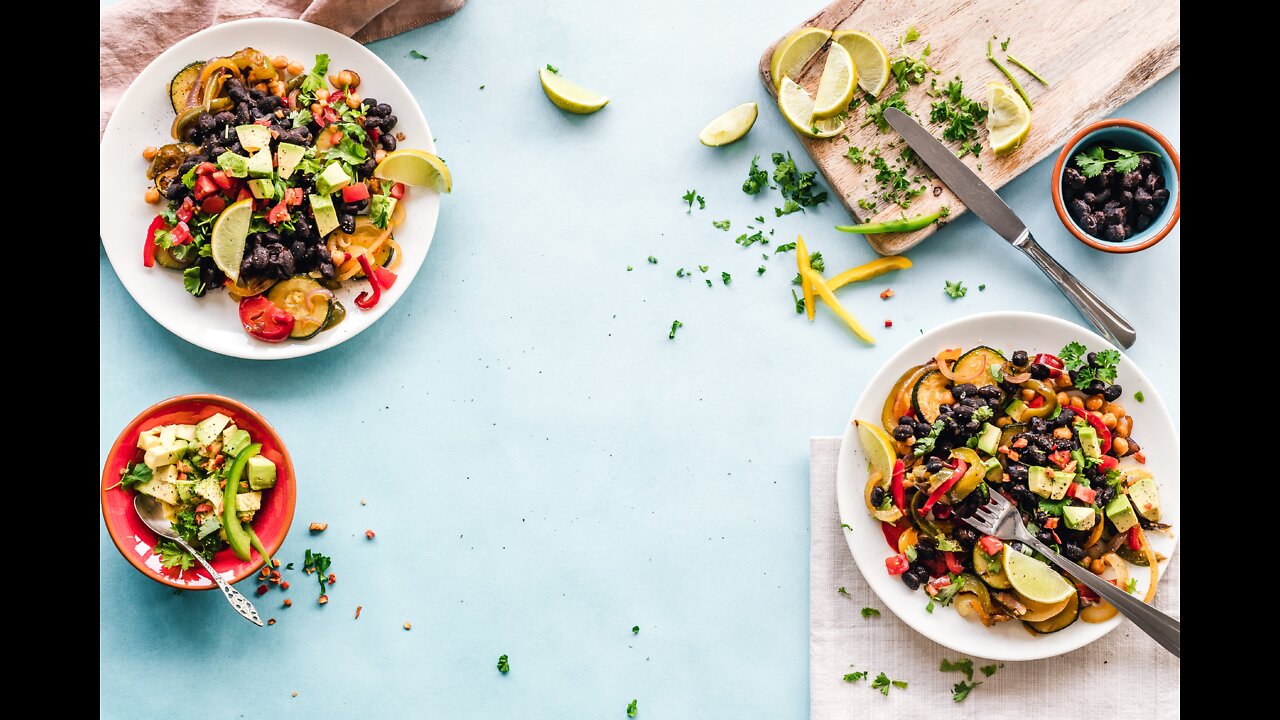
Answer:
[{"xmin": 100, "ymin": 395, "xmax": 298, "ymax": 591}]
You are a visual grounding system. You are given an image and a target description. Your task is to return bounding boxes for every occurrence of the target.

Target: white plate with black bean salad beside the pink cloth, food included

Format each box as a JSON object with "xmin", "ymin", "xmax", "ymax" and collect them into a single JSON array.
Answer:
[{"xmin": 99, "ymin": 19, "xmax": 449, "ymax": 360}]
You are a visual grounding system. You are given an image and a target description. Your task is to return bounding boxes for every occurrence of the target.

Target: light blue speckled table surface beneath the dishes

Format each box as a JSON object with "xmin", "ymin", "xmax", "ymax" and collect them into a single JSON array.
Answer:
[{"xmin": 99, "ymin": 0, "xmax": 1181, "ymax": 719}]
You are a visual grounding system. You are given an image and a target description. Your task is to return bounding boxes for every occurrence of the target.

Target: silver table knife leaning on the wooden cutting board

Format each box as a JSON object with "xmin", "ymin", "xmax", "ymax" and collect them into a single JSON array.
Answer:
[{"xmin": 884, "ymin": 108, "xmax": 1138, "ymax": 347}]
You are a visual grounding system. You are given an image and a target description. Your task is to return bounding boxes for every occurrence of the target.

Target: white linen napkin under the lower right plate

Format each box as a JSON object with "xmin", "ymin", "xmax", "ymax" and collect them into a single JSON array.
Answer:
[{"xmin": 809, "ymin": 437, "xmax": 1181, "ymax": 720}]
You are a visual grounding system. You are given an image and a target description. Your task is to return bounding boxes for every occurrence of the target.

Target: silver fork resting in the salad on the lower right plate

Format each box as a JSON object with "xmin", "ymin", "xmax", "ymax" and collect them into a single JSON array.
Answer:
[{"xmin": 963, "ymin": 492, "xmax": 1183, "ymax": 657}]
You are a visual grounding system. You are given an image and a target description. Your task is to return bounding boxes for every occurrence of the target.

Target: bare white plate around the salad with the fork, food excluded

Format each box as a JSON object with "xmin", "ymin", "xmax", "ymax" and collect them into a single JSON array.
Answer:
[{"xmin": 836, "ymin": 313, "xmax": 1181, "ymax": 660}]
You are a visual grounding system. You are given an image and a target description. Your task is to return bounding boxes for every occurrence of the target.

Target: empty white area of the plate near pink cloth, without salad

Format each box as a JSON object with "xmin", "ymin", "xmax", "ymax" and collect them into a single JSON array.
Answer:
[{"xmin": 99, "ymin": 19, "xmax": 440, "ymax": 360}]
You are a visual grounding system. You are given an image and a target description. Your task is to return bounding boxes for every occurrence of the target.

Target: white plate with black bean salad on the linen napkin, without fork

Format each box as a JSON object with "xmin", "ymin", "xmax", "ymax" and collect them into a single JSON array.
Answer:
[{"xmin": 837, "ymin": 313, "xmax": 1181, "ymax": 660}]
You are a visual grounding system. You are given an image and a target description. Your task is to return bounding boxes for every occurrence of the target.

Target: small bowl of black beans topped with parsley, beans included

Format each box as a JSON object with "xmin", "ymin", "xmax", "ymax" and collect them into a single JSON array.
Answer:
[{"xmin": 1052, "ymin": 118, "xmax": 1179, "ymax": 252}]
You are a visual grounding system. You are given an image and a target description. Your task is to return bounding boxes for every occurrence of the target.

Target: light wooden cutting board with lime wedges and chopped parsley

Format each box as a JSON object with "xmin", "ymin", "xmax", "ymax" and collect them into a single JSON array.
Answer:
[{"xmin": 760, "ymin": 0, "xmax": 1181, "ymax": 255}]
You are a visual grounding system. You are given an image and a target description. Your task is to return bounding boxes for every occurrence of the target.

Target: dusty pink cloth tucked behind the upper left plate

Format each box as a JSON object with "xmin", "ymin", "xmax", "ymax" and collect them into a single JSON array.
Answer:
[{"xmin": 97, "ymin": 0, "xmax": 466, "ymax": 137}]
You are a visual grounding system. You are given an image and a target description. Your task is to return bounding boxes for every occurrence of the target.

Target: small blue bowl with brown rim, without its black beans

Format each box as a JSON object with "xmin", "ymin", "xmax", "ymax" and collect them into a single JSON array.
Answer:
[{"xmin": 1052, "ymin": 118, "xmax": 1181, "ymax": 252}]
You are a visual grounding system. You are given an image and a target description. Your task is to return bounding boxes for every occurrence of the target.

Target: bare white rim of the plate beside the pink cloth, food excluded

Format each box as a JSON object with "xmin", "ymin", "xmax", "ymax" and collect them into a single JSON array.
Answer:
[{"xmin": 99, "ymin": 18, "xmax": 440, "ymax": 360}]
